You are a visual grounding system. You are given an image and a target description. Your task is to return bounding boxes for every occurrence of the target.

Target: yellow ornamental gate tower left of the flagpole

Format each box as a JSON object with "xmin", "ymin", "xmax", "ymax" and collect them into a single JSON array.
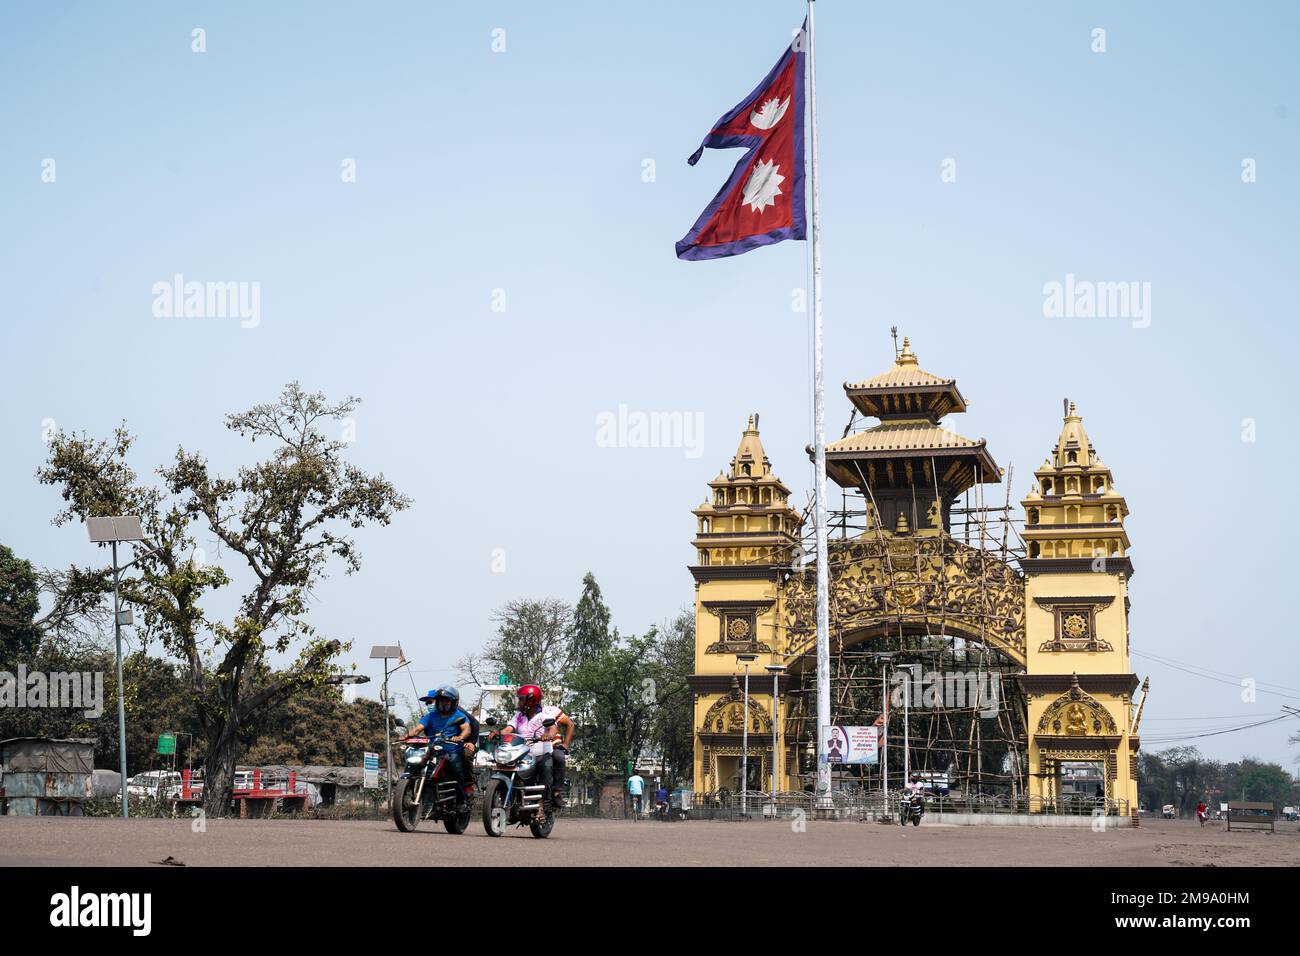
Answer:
[{"xmin": 690, "ymin": 415, "xmax": 802, "ymax": 792}]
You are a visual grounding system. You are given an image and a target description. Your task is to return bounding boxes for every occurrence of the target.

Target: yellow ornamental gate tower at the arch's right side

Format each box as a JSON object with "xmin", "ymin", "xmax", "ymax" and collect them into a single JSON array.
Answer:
[{"xmin": 1022, "ymin": 402, "xmax": 1139, "ymax": 813}]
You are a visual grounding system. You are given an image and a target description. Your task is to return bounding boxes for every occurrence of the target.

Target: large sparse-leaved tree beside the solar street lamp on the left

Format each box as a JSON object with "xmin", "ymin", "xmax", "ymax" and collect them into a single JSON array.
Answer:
[{"xmin": 38, "ymin": 382, "xmax": 411, "ymax": 816}]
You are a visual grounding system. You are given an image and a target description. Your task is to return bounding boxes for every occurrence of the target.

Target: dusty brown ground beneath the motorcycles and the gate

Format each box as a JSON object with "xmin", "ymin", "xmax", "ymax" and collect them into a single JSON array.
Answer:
[{"xmin": 0, "ymin": 817, "xmax": 1300, "ymax": 866}]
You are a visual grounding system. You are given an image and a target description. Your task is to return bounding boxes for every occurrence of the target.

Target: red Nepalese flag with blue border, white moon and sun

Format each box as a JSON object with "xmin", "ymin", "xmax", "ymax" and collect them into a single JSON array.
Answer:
[{"xmin": 677, "ymin": 23, "xmax": 807, "ymax": 259}]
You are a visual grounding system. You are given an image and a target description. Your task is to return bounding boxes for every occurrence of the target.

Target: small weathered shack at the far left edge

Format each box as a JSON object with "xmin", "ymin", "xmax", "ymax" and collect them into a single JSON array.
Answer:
[{"xmin": 0, "ymin": 737, "xmax": 95, "ymax": 817}]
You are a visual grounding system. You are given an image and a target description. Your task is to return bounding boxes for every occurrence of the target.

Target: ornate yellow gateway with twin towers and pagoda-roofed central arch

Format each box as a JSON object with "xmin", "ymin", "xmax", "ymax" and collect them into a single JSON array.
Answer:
[{"xmin": 690, "ymin": 338, "xmax": 1141, "ymax": 813}]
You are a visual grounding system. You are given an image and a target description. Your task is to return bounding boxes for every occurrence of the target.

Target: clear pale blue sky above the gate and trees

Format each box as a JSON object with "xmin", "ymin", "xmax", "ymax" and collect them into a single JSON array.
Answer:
[{"xmin": 0, "ymin": 0, "xmax": 1300, "ymax": 766}]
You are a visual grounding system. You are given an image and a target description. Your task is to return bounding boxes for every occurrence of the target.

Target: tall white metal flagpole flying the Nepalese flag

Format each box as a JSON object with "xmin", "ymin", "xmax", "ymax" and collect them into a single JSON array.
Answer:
[{"xmin": 807, "ymin": 0, "xmax": 831, "ymax": 806}]
